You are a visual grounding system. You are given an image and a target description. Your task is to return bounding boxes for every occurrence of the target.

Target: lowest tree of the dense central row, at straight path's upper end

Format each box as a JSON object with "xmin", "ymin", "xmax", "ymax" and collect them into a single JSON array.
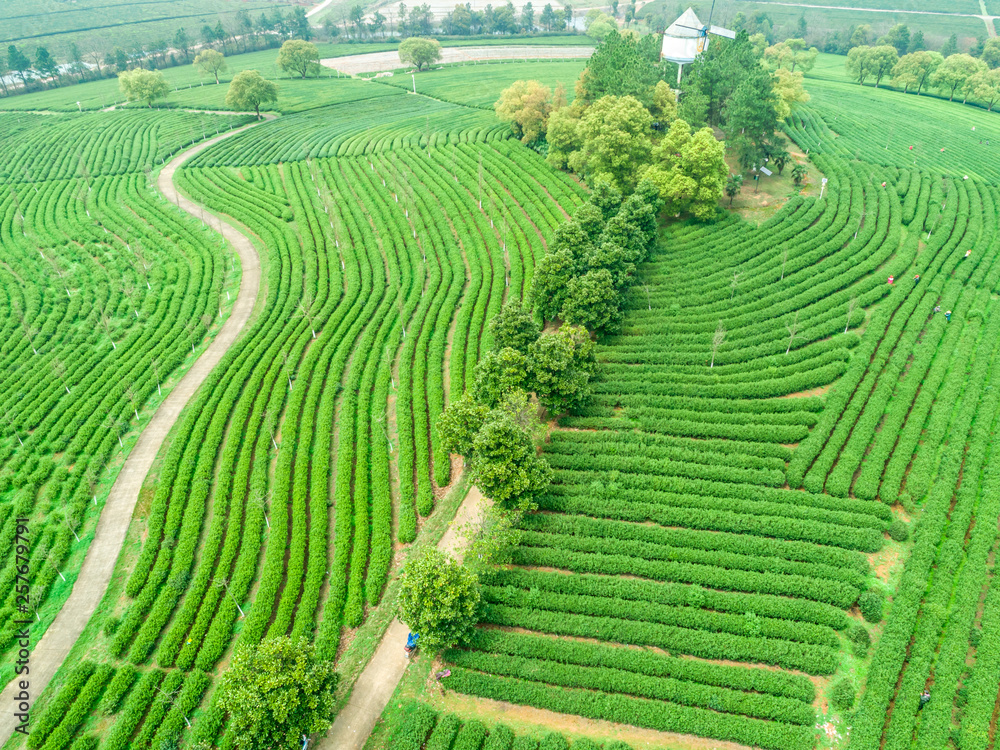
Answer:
[{"xmin": 470, "ymin": 410, "xmax": 552, "ymax": 512}]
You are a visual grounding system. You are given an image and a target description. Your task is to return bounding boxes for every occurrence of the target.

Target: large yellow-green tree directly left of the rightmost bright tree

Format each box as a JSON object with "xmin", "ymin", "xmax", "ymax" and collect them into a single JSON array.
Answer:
[{"xmin": 569, "ymin": 96, "xmax": 652, "ymax": 192}]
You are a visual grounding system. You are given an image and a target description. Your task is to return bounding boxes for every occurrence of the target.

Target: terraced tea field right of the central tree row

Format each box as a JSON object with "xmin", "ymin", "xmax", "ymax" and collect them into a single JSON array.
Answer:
[{"xmin": 436, "ymin": 60, "xmax": 1000, "ymax": 750}]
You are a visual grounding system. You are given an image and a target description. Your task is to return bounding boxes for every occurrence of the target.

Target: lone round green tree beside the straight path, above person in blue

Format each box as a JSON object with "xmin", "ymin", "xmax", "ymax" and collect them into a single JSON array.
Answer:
[{"xmin": 397, "ymin": 548, "xmax": 482, "ymax": 653}]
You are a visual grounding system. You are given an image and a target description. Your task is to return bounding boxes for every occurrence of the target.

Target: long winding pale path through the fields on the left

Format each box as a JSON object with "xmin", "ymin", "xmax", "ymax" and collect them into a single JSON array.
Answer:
[{"xmin": 0, "ymin": 117, "xmax": 270, "ymax": 745}]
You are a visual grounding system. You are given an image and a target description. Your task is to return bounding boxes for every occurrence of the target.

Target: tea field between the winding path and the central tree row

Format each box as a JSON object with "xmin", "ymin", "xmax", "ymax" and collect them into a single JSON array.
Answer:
[{"xmin": 9, "ymin": 78, "xmax": 583, "ymax": 748}]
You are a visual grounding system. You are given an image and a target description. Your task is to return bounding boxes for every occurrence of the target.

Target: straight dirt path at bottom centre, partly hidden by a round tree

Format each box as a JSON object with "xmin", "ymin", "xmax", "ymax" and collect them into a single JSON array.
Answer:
[{"xmin": 316, "ymin": 486, "xmax": 489, "ymax": 750}]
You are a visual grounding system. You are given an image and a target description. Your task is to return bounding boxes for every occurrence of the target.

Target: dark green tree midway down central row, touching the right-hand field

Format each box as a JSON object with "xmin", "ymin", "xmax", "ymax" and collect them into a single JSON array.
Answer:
[{"xmin": 528, "ymin": 325, "xmax": 597, "ymax": 414}]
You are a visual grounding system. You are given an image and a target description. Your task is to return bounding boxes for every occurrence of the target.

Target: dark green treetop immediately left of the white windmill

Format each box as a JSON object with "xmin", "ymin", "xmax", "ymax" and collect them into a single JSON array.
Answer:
[{"xmin": 581, "ymin": 30, "xmax": 663, "ymax": 106}]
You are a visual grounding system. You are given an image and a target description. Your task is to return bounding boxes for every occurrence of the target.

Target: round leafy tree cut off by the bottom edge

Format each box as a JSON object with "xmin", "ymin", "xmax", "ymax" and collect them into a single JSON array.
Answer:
[{"xmin": 219, "ymin": 636, "xmax": 338, "ymax": 750}]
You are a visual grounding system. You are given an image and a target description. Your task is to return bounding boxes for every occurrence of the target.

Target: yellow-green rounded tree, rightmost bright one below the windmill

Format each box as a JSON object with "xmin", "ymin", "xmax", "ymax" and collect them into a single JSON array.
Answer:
[{"xmin": 643, "ymin": 120, "xmax": 729, "ymax": 220}]
